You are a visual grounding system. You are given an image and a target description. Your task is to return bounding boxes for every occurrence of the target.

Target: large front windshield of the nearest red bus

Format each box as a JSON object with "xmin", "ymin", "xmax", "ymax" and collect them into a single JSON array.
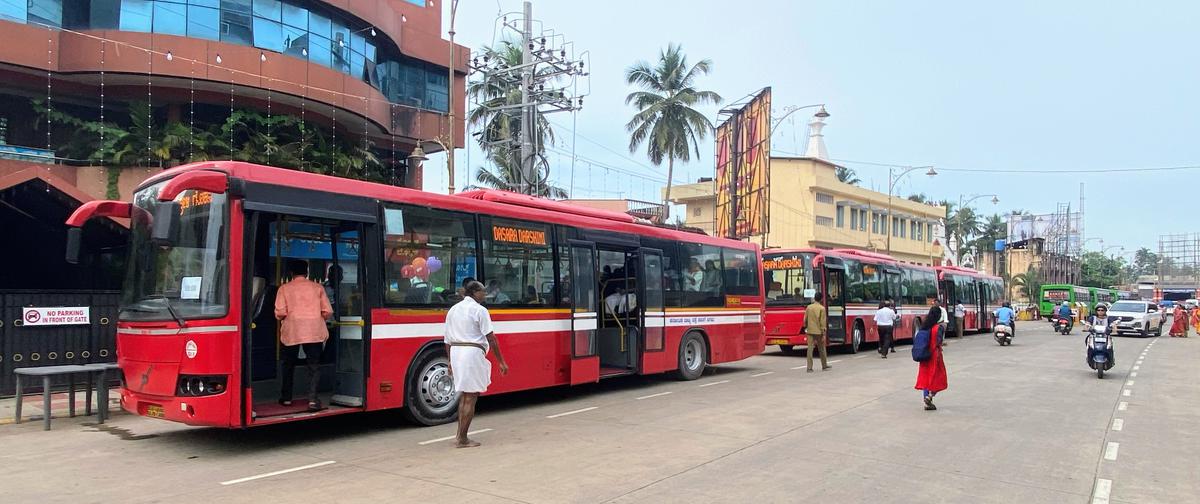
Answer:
[{"xmin": 120, "ymin": 181, "xmax": 229, "ymax": 320}]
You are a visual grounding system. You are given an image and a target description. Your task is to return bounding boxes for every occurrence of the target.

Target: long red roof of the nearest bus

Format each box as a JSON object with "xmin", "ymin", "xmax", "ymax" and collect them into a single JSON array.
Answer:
[{"xmin": 138, "ymin": 161, "xmax": 758, "ymax": 250}]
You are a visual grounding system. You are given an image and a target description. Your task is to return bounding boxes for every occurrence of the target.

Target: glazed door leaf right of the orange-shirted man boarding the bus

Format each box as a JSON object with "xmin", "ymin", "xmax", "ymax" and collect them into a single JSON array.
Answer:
[{"xmin": 325, "ymin": 223, "xmax": 367, "ymax": 407}]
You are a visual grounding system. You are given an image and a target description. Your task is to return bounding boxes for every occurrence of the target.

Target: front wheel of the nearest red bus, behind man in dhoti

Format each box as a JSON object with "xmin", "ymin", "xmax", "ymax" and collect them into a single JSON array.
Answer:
[{"xmin": 403, "ymin": 347, "xmax": 458, "ymax": 425}]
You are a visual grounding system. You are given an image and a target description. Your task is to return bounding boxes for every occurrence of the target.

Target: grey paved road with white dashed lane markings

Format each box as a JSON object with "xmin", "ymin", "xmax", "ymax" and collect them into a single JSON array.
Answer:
[{"xmin": 0, "ymin": 322, "xmax": 1200, "ymax": 504}]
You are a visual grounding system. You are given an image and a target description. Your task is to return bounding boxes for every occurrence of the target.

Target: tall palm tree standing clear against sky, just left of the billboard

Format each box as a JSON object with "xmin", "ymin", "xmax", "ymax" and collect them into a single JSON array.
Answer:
[{"xmin": 625, "ymin": 43, "xmax": 721, "ymax": 217}]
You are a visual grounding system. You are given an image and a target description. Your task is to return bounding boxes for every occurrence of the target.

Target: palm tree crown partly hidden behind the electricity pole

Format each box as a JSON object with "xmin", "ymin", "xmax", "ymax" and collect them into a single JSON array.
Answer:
[{"xmin": 467, "ymin": 41, "xmax": 554, "ymax": 159}]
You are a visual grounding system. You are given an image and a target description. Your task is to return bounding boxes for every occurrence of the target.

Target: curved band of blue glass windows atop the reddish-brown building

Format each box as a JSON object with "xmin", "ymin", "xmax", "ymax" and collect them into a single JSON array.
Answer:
[{"xmin": 0, "ymin": 0, "xmax": 450, "ymax": 113}]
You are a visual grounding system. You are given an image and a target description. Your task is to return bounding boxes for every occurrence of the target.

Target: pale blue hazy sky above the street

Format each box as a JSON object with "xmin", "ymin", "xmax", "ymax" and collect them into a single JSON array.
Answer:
[{"xmin": 425, "ymin": 0, "xmax": 1200, "ymax": 256}]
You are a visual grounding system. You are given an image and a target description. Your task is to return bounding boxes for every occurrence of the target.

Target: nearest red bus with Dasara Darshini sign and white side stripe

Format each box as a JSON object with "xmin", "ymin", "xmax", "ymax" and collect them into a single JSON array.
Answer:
[{"xmin": 67, "ymin": 162, "xmax": 763, "ymax": 427}]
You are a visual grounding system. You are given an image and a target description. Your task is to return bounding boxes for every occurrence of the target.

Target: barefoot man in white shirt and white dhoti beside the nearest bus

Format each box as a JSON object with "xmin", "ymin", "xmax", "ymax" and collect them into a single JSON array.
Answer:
[{"xmin": 443, "ymin": 282, "xmax": 509, "ymax": 448}]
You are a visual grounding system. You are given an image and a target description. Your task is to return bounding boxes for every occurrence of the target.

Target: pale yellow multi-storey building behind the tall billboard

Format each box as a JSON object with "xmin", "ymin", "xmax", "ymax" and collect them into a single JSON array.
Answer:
[{"xmin": 671, "ymin": 157, "xmax": 946, "ymax": 265}]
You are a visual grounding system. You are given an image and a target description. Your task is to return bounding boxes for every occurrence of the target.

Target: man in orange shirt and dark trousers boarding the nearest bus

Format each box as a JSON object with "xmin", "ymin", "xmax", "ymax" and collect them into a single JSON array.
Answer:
[{"xmin": 275, "ymin": 260, "xmax": 334, "ymax": 412}]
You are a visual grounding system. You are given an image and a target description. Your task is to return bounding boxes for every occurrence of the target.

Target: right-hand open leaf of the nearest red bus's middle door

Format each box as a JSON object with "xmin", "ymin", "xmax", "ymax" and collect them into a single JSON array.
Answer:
[{"xmin": 637, "ymin": 248, "xmax": 668, "ymax": 373}]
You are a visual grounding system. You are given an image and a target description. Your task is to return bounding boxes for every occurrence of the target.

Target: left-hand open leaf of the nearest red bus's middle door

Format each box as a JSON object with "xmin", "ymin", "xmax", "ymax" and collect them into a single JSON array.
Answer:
[{"xmin": 563, "ymin": 240, "xmax": 600, "ymax": 385}]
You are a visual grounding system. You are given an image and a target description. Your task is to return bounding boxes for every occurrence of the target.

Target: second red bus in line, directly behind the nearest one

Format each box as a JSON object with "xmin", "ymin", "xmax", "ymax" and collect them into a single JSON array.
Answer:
[{"xmin": 762, "ymin": 248, "xmax": 937, "ymax": 353}]
